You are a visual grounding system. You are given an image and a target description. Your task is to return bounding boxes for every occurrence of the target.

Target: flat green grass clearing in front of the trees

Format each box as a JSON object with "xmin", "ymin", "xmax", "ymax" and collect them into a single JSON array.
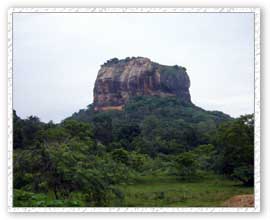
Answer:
[{"xmin": 118, "ymin": 175, "xmax": 253, "ymax": 207}]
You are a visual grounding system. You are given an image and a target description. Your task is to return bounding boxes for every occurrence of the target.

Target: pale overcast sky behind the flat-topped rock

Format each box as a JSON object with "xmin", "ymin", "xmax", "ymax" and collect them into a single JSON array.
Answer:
[{"xmin": 13, "ymin": 13, "xmax": 254, "ymax": 122}]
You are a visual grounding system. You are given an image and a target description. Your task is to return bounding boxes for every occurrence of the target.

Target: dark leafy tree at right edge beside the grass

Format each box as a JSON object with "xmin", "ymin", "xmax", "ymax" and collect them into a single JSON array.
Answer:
[{"xmin": 213, "ymin": 115, "xmax": 254, "ymax": 185}]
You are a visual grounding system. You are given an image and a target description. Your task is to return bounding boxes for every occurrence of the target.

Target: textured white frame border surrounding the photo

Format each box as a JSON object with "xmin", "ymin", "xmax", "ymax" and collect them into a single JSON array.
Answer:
[{"xmin": 7, "ymin": 8, "xmax": 260, "ymax": 212}]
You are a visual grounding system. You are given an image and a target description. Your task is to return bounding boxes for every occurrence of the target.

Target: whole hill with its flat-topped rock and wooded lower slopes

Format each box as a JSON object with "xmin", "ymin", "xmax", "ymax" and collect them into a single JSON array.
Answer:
[{"xmin": 69, "ymin": 57, "xmax": 232, "ymax": 155}]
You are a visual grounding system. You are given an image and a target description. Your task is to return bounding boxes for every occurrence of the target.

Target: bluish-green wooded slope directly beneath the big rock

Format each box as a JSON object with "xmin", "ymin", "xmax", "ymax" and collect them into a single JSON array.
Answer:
[{"xmin": 69, "ymin": 96, "xmax": 232, "ymax": 155}]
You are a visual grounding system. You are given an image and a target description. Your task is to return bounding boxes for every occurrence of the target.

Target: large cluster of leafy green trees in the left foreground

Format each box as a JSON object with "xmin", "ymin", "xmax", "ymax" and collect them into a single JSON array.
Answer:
[{"xmin": 14, "ymin": 117, "xmax": 129, "ymax": 206}]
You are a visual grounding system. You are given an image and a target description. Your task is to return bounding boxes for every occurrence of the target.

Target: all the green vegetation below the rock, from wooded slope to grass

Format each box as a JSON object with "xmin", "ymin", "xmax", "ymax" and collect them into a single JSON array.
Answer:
[{"xmin": 13, "ymin": 96, "xmax": 254, "ymax": 207}]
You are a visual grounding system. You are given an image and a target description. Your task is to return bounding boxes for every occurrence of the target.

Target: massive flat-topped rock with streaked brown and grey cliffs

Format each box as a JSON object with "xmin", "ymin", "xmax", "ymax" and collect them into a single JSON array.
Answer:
[{"xmin": 94, "ymin": 57, "xmax": 191, "ymax": 111}]
